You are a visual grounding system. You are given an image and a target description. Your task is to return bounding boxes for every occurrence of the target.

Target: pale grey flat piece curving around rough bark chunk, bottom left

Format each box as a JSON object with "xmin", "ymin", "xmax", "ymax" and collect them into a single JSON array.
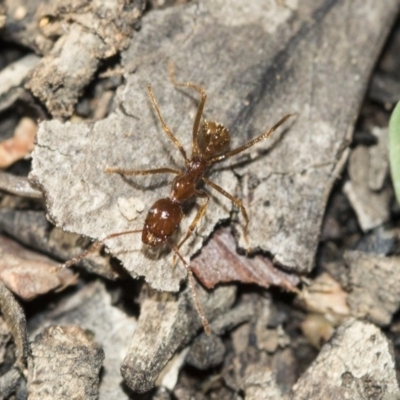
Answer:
[{"xmin": 29, "ymin": 282, "xmax": 136, "ymax": 400}]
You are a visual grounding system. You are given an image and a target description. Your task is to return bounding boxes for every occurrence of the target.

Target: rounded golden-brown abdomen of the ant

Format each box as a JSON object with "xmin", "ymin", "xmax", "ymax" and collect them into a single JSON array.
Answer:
[{"xmin": 197, "ymin": 121, "xmax": 231, "ymax": 158}]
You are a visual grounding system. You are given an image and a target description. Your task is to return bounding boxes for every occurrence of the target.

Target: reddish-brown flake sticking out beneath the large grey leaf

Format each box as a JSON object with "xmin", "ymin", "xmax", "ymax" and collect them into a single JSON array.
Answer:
[{"xmin": 191, "ymin": 228, "xmax": 300, "ymax": 291}]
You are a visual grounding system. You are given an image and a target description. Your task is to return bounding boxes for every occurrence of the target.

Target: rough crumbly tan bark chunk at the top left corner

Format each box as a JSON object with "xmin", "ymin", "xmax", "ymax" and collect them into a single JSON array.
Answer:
[{"xmin": 26, "ymin": 0, "xmax": 146, "ymax": 117}]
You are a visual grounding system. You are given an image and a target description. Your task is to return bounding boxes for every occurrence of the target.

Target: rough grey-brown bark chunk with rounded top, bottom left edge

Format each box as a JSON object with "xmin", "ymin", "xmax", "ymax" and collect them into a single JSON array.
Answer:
[{"xmin": 28, "ymin": 326, "xmax": 104, "ymax": 400}]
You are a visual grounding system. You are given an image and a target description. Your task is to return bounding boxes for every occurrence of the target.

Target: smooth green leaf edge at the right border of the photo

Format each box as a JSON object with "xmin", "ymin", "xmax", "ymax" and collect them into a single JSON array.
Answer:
[{"xmin": 389, "ymin": 101, "xmax": 400, "ymax": 204}]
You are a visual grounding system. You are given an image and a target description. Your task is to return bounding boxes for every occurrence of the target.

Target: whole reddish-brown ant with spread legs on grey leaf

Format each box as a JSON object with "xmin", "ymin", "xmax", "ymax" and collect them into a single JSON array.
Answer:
[{"xmin": 61, "ymin": 63, "xmax": 293, "ymax": 334}]
